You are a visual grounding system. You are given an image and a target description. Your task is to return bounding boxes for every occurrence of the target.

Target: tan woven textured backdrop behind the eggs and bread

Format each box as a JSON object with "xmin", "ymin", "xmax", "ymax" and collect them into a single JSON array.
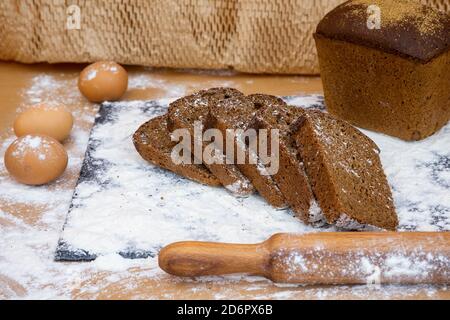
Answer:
[{"xmin": 0, "ymin": 0, "xmax": 450, "ymax": 74}]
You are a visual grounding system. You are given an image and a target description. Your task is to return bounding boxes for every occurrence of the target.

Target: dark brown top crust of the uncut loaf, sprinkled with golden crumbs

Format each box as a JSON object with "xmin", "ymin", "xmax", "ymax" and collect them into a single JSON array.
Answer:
[{"xmin": 315, "ymin": 0, "xmax": 450, "ymax": 63}]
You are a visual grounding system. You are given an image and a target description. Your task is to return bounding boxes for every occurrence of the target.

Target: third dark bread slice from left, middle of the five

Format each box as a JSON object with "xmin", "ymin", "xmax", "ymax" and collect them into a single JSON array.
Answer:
[{"xmin": 206, "ymin": 95, "xmax": 287, "ymax": 208}]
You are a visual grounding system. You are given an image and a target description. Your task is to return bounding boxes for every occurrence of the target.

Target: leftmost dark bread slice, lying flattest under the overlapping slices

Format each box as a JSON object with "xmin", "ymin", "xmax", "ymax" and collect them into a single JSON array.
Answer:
[{"xmin": 133, "ymin": 115, "xmax": 220, "ymax": 186}]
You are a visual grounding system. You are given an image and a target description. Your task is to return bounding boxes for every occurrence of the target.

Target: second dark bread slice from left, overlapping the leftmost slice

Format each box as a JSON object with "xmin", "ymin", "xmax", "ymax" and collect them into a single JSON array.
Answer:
[{"xmin": 168, "ymin": 88, "xmax": 254, "ymax": 196}]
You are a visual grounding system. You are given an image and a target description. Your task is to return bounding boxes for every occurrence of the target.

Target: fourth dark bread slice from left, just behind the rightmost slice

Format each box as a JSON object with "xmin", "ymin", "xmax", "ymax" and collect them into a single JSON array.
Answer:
[{"xmin": 248, "ymin": 94, "xmax": 323, "ymax": 223}]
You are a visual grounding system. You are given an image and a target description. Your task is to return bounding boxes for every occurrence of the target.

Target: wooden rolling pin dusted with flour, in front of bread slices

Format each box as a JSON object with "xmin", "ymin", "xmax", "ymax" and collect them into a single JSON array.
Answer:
[{"xmin": 159, "ymin": 232, "xmax": 450, "ymax": 285}]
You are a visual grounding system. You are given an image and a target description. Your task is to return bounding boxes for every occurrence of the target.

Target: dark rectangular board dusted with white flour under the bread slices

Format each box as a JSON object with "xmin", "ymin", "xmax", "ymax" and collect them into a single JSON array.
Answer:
[{"xmin": 55, "ymin": 95, "xmax": 450, "ymax": 261}]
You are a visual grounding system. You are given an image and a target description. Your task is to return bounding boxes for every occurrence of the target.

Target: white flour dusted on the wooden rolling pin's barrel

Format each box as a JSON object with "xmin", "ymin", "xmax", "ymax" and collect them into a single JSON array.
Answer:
[{"xmin": 273, "ymin": 247, "xmax": 450, "ymax": 284}]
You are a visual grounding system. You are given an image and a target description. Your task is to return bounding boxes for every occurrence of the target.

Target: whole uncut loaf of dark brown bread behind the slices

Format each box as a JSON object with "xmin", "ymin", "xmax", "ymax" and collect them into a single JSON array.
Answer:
[{"xmin": 314, "ymin": 0, "xmax": 450, "ymax": 140}]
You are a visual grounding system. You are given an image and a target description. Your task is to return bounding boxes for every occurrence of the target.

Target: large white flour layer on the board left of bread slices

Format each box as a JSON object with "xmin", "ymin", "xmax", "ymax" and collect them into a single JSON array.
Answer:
[{"xmin": 58, "ymin": 100, "xmax": 318, "ymax": 255}]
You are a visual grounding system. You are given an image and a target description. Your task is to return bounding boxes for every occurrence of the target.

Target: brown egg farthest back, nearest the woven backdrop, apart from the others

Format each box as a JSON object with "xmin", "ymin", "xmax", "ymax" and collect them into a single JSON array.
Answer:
[{"xmin": 78, "ymin": 61, "xmax": 128, "ymax": 102}]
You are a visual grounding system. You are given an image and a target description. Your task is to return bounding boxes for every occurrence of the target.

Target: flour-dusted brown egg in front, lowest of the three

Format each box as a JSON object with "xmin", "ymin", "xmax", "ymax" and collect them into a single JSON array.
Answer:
[{"xmin": 5, "ymin": 135, "xmax": 68, "ymax": 185}]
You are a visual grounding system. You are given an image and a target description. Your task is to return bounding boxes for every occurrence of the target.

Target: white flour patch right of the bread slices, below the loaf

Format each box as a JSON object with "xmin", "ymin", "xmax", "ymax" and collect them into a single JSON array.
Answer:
[{"xmin": 362, "ymin": 123, "xmax": 450, "ymax": 231}]
